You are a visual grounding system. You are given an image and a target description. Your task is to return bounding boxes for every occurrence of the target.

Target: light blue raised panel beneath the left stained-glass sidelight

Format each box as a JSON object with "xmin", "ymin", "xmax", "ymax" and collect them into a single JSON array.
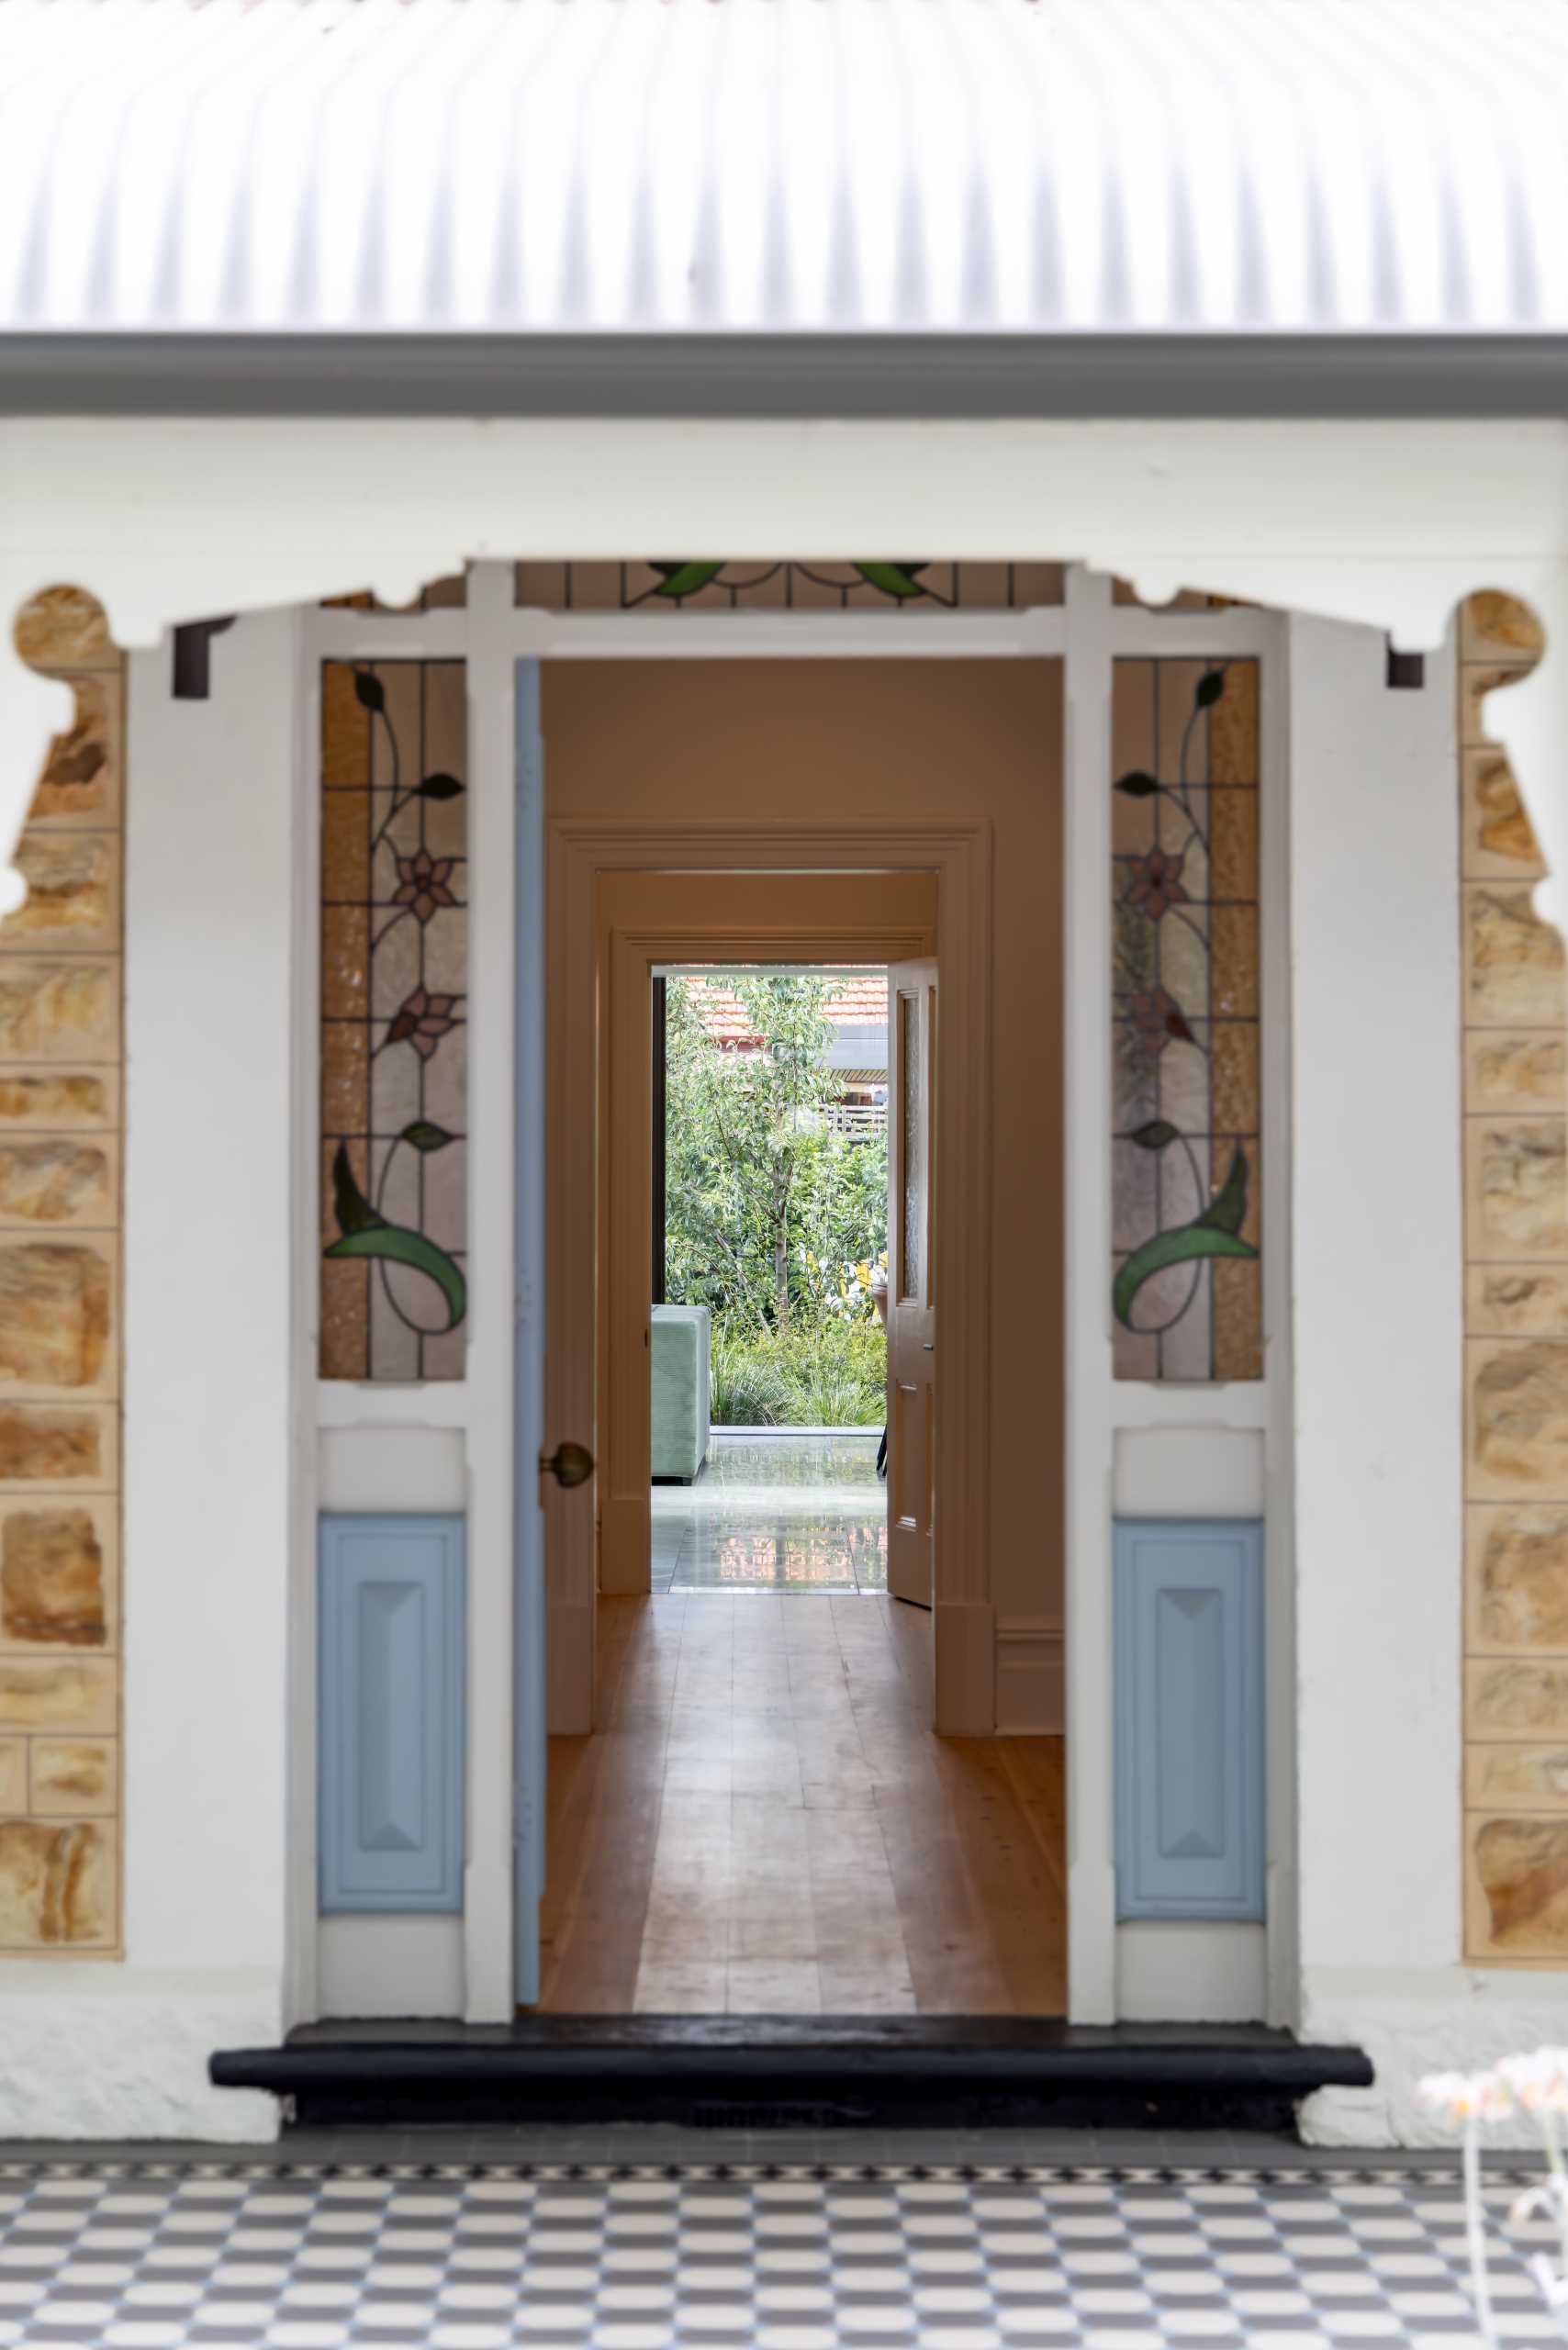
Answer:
[{"xmin": 319, "ymin": 1516, "xmax": 465, "ymax": 1915}]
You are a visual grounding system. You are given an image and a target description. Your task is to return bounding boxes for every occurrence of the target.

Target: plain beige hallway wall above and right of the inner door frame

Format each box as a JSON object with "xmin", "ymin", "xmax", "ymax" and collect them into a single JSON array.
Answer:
[{"xmin": 543, "ymin": 660, "xmax": 1062, "ymax": 1619}]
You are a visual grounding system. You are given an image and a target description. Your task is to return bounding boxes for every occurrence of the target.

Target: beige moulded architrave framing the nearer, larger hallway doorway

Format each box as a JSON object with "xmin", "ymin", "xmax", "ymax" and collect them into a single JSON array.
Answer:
[{"xmin": 545, "ymin": 818, "xmax": 994, "ymax": 1737}]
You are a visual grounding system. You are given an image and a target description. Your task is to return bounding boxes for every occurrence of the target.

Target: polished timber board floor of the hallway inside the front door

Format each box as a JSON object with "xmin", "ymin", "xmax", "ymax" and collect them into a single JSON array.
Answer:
[{"xmin": 538, "ymin": 1591, "xmax": 1068, "ymax": 2016}]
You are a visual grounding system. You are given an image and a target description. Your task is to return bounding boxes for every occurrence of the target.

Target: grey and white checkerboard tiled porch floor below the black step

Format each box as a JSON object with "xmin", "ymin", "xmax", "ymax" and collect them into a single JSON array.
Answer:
[{"xmin": 0, "ymin": 2160, "xmax": 1551, "ymax": 2350}]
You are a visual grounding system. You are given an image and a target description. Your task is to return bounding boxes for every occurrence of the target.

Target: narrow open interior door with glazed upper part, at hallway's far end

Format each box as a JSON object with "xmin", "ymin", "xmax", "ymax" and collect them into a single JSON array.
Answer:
[{"xmin": 889, "ymin": 961, "xmax": 935, "ymax": 1607}]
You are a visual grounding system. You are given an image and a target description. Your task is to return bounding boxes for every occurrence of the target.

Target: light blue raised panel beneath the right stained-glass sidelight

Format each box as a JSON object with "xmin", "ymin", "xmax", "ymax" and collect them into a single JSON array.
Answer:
[{"xmin": 1116, "ymin": 1518, "xmax": 1265, "ymax": 1920}]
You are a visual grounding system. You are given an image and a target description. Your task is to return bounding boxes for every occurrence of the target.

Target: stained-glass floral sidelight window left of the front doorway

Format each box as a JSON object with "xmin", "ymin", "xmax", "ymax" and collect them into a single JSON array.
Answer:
[{"xmin": 319, "ymin": 660, "xmax": 468, "ymax": 1380}]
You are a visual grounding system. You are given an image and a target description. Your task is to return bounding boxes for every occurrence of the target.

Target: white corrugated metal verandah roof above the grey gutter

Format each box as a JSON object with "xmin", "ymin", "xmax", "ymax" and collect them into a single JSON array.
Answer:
[{"xmin": 0, "ymin": 0, "xmax": 1568, "ymax": 334}]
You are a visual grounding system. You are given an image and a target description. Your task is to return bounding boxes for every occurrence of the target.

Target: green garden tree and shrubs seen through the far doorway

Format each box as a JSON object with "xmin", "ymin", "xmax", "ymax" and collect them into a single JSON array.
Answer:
[{"xmin": 666, "ymin": 973, "xmax": 886, "ymax": 1427}]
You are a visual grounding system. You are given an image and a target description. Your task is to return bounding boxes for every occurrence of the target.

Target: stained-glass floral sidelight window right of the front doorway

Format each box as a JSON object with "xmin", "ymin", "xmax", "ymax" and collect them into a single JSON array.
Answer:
[{"xmin": 1112, "ymin": 660, "xmax": 1262, "ymax": 1380}]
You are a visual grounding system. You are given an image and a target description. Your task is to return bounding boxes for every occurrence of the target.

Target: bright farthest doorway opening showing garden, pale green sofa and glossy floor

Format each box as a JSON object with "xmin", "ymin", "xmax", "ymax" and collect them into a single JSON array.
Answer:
[{"xmin": 649, "ymin": 964, "xmax": 889, "ymax": 1598}]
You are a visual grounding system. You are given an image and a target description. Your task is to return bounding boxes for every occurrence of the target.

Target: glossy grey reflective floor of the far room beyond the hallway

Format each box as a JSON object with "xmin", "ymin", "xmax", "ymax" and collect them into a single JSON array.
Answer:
[{"xmin": 654, "ymin": 1428, "xmax": 886, "ymax": 1595}]
